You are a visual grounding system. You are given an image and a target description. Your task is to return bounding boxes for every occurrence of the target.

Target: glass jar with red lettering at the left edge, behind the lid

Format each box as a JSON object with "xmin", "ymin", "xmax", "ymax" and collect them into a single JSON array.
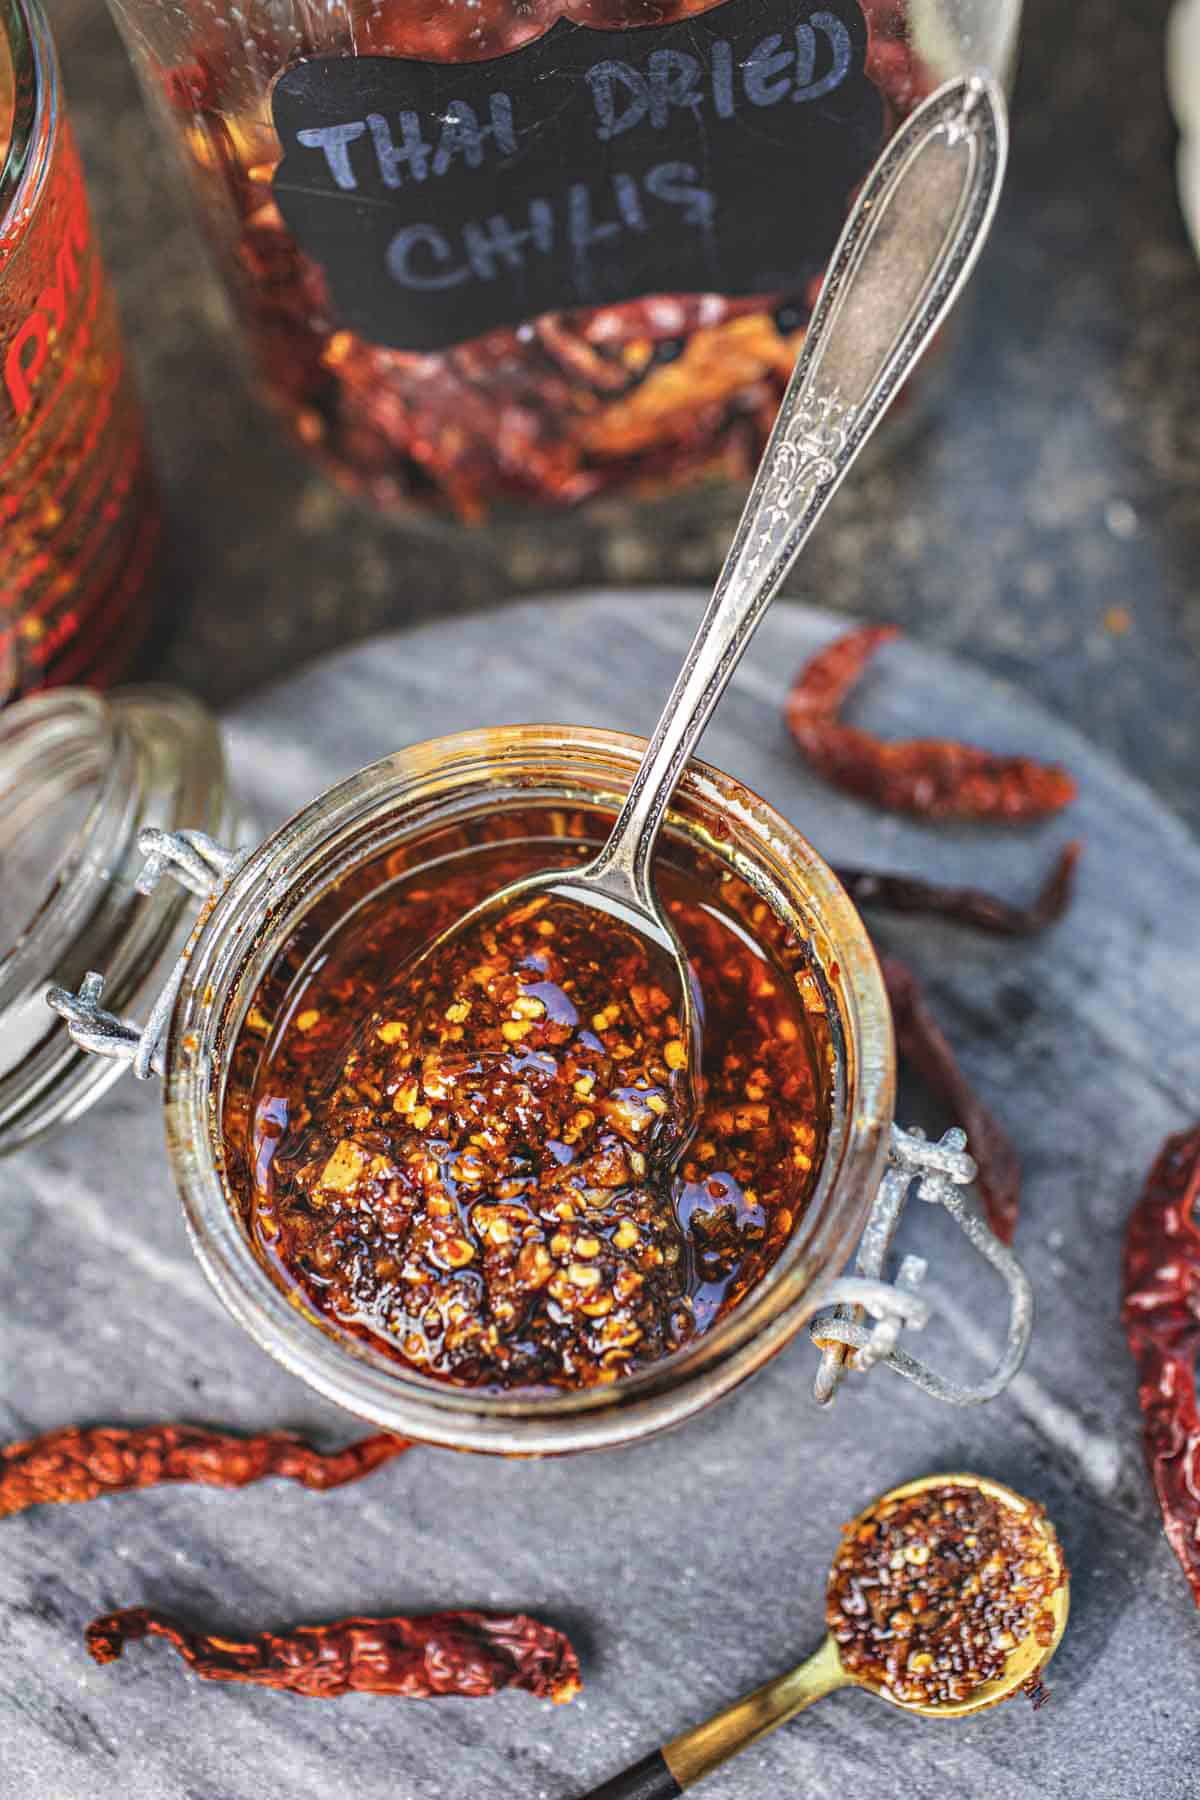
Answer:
[{"xmin": 0, "ymin": 0, "xmax": 158, "ymax": 706}]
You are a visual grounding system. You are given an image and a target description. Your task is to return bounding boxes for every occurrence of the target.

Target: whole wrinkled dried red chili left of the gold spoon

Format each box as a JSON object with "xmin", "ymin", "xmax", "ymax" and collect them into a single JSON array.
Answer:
[{"xmin": 86, "ymin": 1606, "xmax": 581, "ymax": 1701}]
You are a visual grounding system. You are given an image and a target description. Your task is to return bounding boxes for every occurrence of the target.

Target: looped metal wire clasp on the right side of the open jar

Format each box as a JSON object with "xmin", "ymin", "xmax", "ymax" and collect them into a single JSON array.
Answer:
[{"xmin": 808, "ymin": 1125, "xmax": 1033, "ymax": 1406}]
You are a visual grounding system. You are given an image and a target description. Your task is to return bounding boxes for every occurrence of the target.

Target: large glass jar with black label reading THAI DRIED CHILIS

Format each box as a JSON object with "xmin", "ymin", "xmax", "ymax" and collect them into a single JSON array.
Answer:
[{"xmin": 103, "ymin": 0, "xmax": 1020, "ymax": 522}]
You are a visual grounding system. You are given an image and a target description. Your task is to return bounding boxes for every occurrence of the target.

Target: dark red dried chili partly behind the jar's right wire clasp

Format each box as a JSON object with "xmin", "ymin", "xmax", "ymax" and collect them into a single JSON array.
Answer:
[{"xmin": 880, "ymin": 956, "xmax": 1020, "ymax": 1244}]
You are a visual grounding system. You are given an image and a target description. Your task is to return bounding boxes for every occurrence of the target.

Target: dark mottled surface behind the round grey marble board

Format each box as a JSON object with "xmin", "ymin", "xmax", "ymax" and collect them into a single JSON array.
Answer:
[{"xmin": 47, "ymin": 0, "xmax": 1200, "ymax": 824}]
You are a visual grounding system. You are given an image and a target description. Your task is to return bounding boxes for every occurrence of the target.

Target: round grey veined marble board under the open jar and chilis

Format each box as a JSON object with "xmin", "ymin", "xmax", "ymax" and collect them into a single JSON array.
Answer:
[{"xmin": 0, "ymin": 594, "xmax": 1200, "ymax": 1800}]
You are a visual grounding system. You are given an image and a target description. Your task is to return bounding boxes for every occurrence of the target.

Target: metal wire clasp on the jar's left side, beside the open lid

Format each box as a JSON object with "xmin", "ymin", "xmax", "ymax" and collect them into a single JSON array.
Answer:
[{"xmin": 47, "ymin": 824, "xmax": 250, "ymax": 1082}]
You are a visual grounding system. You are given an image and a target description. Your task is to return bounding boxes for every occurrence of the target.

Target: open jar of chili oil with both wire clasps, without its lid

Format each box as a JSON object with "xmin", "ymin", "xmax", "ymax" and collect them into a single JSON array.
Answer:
[{"xmin": 9, "ymin": 712, "xmax": 1007, "ymax": 1454}]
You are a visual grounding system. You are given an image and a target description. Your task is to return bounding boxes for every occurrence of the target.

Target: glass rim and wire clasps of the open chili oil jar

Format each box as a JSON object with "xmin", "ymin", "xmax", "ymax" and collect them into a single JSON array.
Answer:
[{"xmin": 30, "ymin": 709, "xmax": 1029, "ymax": 1454}]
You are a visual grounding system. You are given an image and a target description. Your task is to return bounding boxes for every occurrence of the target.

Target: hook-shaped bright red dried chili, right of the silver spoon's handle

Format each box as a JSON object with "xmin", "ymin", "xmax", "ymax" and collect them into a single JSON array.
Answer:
[{"xmin": 784, "ymin": 625, "xmax": 1076, "ymax": 823}]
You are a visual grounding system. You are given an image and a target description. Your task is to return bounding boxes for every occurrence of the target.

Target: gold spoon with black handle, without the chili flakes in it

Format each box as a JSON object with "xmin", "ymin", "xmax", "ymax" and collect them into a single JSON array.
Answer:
[{"xmin": 583, "ymin": 1474, "xmax": 1070, "ymax": 1800}]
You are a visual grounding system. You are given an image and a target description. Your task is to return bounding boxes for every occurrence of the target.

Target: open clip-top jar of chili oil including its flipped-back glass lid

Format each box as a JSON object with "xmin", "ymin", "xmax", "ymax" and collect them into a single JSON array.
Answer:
[{"xmin": 25, "ymin": 709, "xmax": 1029, "ymax": 1454}]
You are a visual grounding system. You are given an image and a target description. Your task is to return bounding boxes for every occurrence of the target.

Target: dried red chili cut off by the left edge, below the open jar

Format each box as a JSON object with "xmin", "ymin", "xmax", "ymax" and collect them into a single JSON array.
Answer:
[{"xmin": 0, "ymin": 1426, "xmax": 410, "ymax": 1519}]
